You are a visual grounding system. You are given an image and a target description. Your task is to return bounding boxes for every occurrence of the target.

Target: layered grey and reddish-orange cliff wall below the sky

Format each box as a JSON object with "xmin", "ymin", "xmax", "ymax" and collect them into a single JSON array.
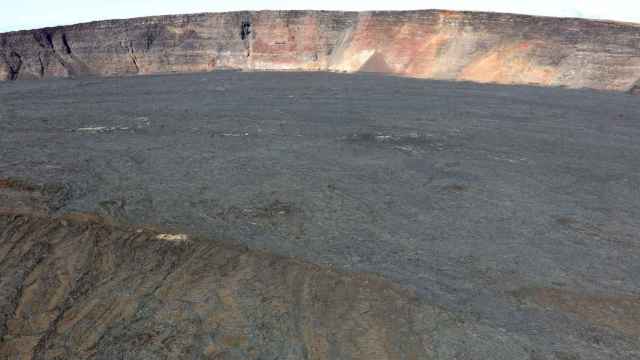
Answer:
[{"xmin": 0, "ymin": 10, "xmax": 640, "ymax": 91}]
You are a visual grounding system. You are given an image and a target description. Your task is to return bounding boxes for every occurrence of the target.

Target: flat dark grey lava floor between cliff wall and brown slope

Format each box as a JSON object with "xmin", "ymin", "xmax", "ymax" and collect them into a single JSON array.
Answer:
[{"xmin": 0, "ymin": 72, "xmax": 640, "ymax": 360}]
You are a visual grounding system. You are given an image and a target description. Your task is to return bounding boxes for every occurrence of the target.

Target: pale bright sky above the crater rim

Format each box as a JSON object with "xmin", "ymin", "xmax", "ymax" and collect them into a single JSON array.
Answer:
[{"xmin": 0, "ymin": 0, "xmax": 640, "ymax": 32}]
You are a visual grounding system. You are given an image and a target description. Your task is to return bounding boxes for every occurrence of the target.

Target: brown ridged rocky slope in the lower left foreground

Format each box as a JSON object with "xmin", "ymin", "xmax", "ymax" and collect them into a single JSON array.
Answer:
[{"xmin": 0, "ymin": 180, "xmax": 535, "ymax": 360}]
